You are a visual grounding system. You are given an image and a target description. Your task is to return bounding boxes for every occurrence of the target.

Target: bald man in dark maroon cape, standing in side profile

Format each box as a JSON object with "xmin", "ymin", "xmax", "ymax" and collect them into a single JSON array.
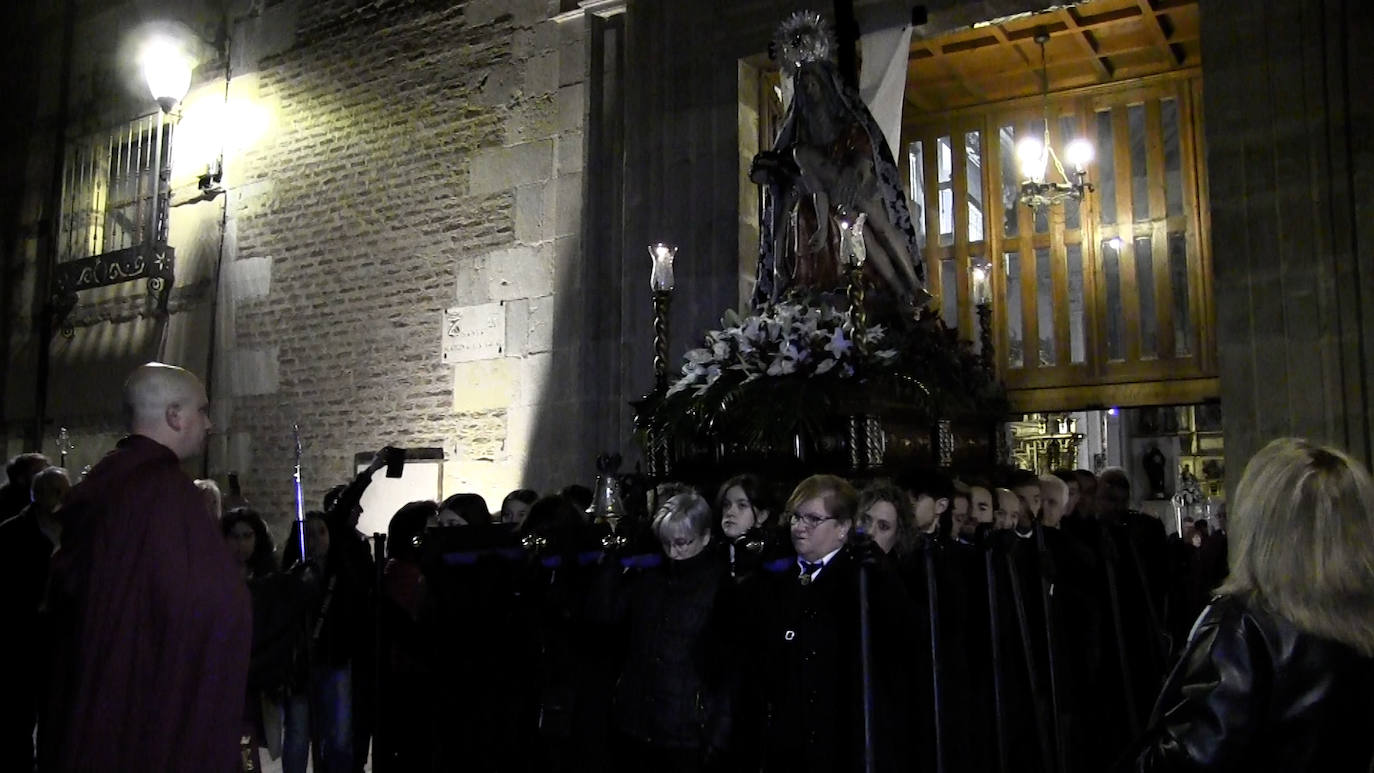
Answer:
[{"xmin": 40, "ymin": 362, "xmax": 251, "ymax": 772}]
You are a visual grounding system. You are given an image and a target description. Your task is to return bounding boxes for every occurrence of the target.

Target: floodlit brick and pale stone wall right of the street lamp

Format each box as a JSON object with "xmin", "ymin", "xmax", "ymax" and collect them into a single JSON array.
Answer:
[{"xmin": 213, "ymin": 0, "xmax": 584, "ymax": 527}]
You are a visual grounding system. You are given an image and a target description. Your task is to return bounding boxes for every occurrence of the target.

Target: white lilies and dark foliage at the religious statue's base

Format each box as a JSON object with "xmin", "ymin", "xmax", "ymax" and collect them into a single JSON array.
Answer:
[{"xmin": 636, "ymin": 291, "xmax": 1004, "ymax": 456}]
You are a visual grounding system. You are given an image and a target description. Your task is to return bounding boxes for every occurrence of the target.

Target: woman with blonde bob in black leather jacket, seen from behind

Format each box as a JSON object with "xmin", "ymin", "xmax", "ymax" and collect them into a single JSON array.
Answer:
[{"xmin": 1117, "ymin": 438, "xmax": 1374, "ymax": 773}]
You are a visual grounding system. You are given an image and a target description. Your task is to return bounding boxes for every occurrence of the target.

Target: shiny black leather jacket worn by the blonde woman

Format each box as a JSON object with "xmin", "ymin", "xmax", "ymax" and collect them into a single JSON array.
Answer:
[{"xmin": 1117, "ymin": 596, "xmax": 1374, "ymax": 773}]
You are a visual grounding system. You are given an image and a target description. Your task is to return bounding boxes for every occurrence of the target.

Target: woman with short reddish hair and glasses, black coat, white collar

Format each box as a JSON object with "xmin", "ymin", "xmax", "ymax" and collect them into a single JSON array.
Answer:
[{"xmin": 741, "ymin": 475, "xmax": 914, "ymax": 773}]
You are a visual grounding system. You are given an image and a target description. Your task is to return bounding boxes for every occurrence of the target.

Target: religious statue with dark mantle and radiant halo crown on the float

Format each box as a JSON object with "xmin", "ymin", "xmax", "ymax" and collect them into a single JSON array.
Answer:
[{"xmin": 749, "ymin": 11, "xmax": 930, "ymax": 309}]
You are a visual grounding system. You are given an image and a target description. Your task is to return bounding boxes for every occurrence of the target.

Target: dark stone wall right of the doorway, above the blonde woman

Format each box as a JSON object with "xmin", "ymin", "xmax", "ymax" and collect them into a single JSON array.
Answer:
[{"xmin": 1201, "ymin": 0, "xmax": 1374, "ymax": 487}]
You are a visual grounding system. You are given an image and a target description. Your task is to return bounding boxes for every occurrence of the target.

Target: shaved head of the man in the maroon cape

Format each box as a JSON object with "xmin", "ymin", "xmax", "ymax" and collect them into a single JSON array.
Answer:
[{"xmin": 124, "ymin": 362, "xmax": 210, "ymax": 459}]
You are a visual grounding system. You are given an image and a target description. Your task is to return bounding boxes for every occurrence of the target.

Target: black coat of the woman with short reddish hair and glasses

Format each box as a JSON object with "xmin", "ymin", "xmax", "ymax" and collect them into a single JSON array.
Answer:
[{"xmin": 738, "ymin": 548, "xmax": 927, "ymax": 773}]
